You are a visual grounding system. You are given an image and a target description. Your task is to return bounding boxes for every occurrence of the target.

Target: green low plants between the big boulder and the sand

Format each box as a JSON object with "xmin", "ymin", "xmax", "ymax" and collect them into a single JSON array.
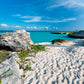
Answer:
[{"xmin": 17, "ymin": 45, "xmax": 45, "ymax": 71}]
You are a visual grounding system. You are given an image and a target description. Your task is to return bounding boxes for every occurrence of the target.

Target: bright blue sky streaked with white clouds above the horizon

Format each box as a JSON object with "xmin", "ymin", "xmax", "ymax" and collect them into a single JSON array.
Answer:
[{"xmin": 0, "ymin": 0, "xmax": 84, "ymax": 31}]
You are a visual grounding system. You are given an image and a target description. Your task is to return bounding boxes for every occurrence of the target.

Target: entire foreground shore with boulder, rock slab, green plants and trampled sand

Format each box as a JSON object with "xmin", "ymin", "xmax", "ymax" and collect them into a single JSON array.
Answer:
[{"xmin": 0, "ymin": 30, "xmax": 84, "ymax": 84}]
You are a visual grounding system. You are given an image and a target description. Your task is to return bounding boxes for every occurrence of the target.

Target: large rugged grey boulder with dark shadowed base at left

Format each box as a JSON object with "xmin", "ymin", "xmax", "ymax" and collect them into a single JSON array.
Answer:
[{"xmin": 0, "ymin": 30, "xmax": 33, "ymax": 51}]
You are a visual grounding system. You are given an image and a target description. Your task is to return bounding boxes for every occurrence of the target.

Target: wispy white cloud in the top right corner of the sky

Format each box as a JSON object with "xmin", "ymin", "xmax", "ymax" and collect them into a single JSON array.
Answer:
[{"xmin": 47, "ymin": 0, "xmax": 84, "ymax": 9}]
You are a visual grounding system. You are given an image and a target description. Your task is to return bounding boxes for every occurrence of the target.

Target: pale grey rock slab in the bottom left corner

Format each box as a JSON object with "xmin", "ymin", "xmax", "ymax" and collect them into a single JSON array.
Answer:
[{"xmin": 0, "ymin": 52, "xmax": 23, "ymax": 84}]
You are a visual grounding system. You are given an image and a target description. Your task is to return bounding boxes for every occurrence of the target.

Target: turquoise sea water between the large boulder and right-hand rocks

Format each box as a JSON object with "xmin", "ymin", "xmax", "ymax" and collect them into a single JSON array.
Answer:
[{"xmin": 30, "ymin": 32, "xmax": 73, "ymax": 43}]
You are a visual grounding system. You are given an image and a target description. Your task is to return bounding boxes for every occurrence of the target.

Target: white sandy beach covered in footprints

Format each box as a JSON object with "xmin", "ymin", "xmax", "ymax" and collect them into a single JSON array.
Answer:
[{"xmin": 25, "ymin": 40, "xmax": 84, "ymax": 84}]
